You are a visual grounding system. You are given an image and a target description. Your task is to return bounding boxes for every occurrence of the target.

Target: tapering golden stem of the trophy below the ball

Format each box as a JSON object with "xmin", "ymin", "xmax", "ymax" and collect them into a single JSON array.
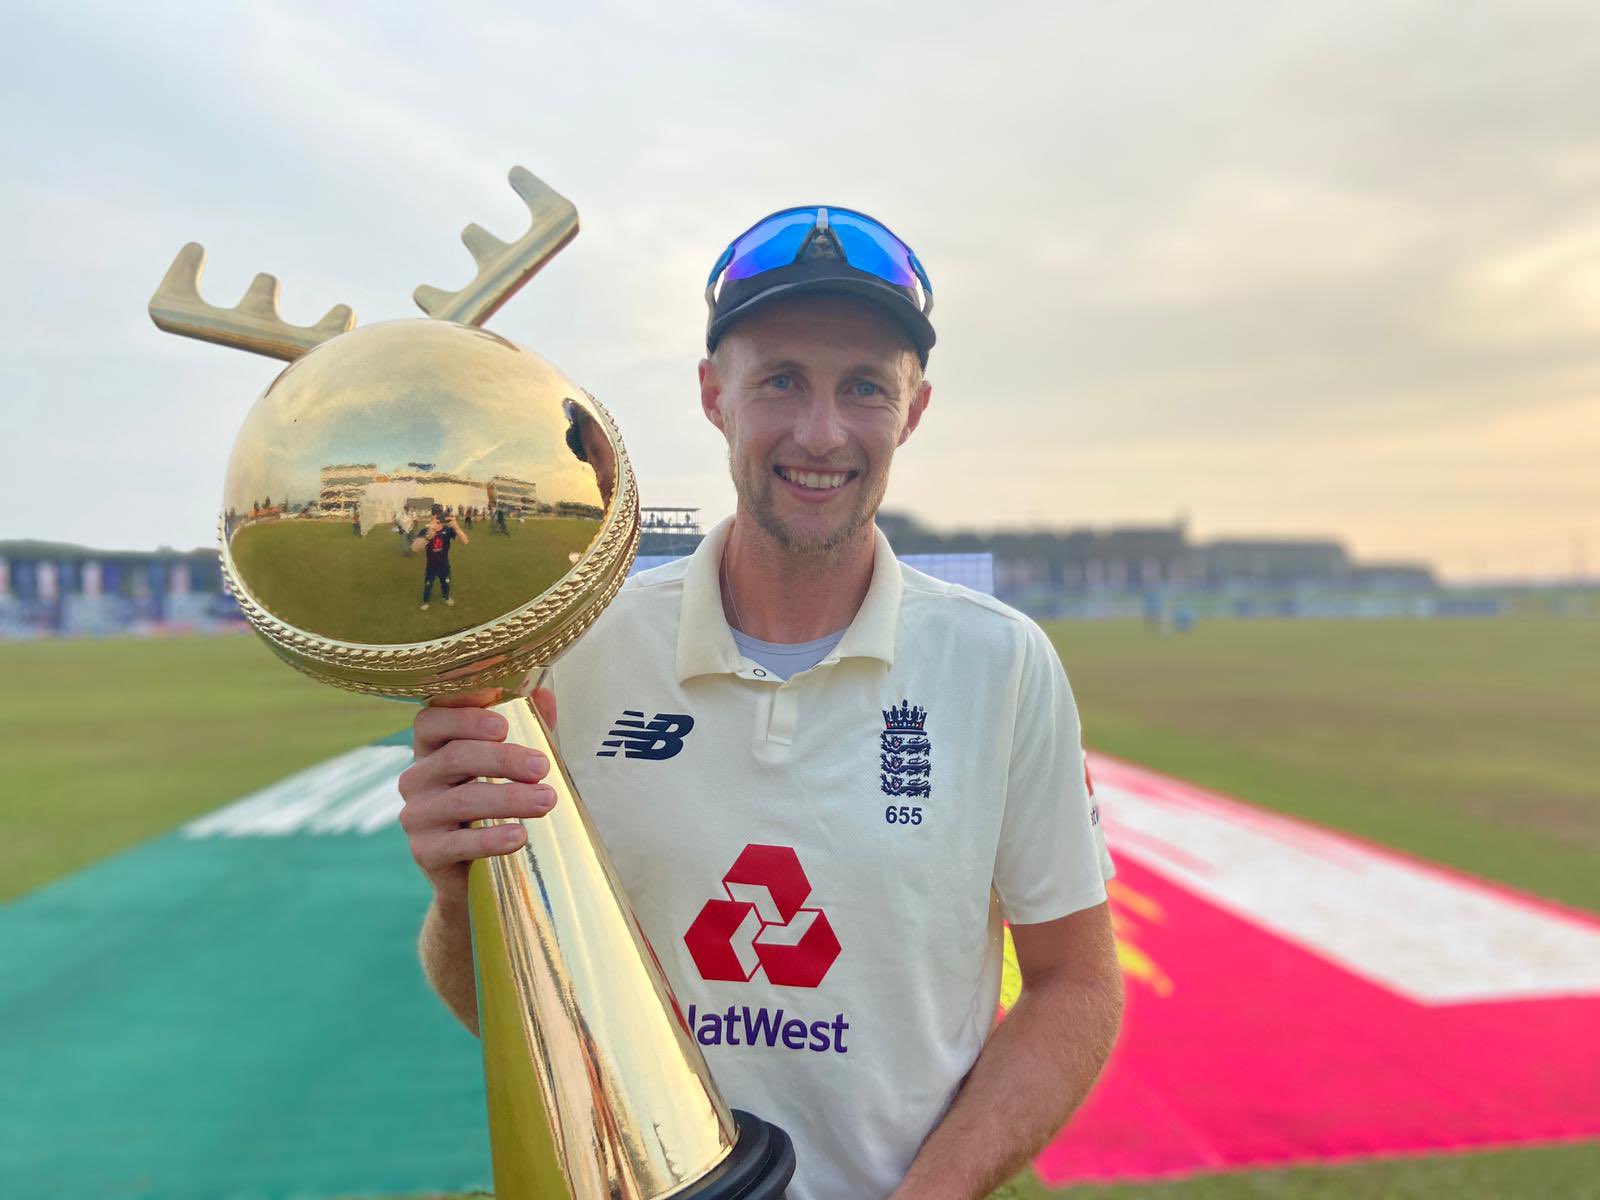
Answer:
[{"xmin": 469, "ymin": 698, "xmax": 777, "ymax": 1200}]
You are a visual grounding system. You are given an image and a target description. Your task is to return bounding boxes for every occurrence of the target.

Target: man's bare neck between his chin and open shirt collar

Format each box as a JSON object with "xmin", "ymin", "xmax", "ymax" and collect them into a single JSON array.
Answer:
[{"xmin": 722, "ymin": 514, "xmax": 877, "ymax": 643}]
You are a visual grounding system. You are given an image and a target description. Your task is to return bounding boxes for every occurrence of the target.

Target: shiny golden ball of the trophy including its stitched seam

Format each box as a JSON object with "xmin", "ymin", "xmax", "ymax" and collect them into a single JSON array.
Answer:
[{"xmin": 222, "ymin": 320, "xmax": 638, "ymax": 698}]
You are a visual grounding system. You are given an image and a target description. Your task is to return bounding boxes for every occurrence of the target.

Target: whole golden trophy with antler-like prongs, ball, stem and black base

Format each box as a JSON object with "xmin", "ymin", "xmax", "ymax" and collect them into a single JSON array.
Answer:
[{"xmin": 150, "ymin": 166, "xmax": 794, "ymax": 1200}]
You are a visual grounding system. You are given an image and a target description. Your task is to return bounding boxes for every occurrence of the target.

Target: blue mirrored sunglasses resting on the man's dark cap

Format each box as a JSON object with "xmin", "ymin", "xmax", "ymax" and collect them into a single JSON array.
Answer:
[{"xmin": 706, "ymin": 205, "xmax": 933, "ymax": 314}]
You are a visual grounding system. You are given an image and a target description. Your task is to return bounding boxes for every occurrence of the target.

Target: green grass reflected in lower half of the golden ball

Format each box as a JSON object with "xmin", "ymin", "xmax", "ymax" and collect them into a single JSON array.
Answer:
[{"xmin": 232, "ymin": 517, "xmax": 598, "ymax": 645}]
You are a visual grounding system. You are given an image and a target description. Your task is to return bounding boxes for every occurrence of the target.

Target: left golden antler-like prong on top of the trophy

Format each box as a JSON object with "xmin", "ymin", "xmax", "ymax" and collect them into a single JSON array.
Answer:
[{"xmin": 150, "ymin": 242, "xmax": 355, "ymax": 362}]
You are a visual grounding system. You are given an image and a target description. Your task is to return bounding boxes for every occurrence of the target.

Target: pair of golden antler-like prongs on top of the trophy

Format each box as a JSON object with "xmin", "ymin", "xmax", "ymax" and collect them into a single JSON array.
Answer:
[{"xmin": 150, "ymin": 166, "xmax": 578, "ymax": 362}]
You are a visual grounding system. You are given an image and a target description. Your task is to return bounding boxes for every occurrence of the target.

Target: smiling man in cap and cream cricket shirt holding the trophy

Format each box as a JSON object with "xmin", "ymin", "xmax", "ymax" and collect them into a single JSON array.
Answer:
[{"xmin": 400, "ymin": 208, "xmax": 1122, "ymax": 1200}]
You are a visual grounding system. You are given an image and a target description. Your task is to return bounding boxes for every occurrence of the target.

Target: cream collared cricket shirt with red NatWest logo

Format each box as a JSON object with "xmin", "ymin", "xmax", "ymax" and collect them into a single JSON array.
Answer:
[{"xmin": 549, "ymin": 520, "xmax": 1112, "ymax": 1200}]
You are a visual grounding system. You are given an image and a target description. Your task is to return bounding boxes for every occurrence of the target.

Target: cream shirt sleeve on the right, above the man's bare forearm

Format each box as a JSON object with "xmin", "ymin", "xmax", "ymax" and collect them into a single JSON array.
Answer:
[{"xmin": 994, "ymin": 621, "xmax": 1115, "ymax": 925}]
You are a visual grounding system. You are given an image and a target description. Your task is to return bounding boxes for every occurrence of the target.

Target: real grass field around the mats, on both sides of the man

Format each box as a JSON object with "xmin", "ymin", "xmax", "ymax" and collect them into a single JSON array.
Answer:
[{"xmin": 0, "ymin": 624, "xmax": 1600, "ymax": 1200}]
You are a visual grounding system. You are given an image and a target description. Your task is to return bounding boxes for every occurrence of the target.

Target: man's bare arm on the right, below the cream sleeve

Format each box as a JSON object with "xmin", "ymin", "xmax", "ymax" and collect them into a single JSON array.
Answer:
[{"xmin": 890, "ymin": 902, "xmax": 1122, "ymax": 1200}]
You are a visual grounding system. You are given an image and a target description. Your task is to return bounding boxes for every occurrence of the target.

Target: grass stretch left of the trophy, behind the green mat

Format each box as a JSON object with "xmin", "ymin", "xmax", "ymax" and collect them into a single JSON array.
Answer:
[{"xmin": 0, "ymin": 634, "xmax": 400, "ymax": 899}]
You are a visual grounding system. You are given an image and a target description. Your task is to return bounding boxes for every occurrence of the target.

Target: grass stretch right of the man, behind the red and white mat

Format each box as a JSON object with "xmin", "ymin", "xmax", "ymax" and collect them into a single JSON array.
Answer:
[{"xmin": 1050, "ymin": 619, "xmax": 1600, "ymax": 912}]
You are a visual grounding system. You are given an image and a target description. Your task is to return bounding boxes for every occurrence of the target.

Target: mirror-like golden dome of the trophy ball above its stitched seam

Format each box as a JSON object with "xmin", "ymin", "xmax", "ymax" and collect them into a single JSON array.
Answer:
[{"xmin": 224, "ymin": 322, "xmax": 616, "ymax": 645}]
